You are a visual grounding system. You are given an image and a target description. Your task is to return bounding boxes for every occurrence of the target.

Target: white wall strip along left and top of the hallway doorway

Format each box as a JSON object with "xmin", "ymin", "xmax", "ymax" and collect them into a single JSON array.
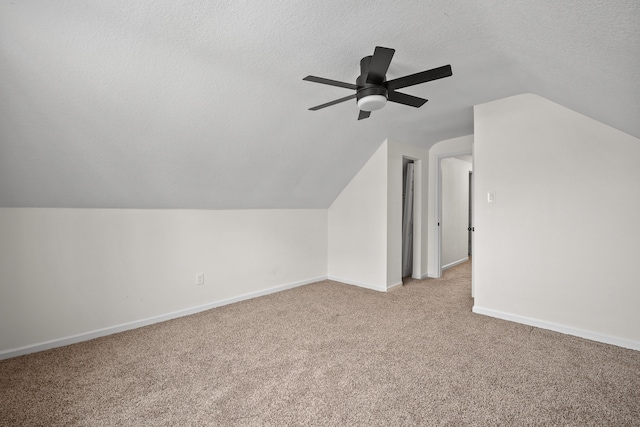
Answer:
[{"xmin": 427, "ymin": 135, "xmax": 474, "ymax": 277}]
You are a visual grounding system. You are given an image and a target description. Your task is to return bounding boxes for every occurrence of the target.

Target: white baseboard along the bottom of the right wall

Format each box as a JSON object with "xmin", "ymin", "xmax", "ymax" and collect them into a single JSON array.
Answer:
[{"xmin": 472, "ymin": 305, "xmax": 640, "ymax": 350}]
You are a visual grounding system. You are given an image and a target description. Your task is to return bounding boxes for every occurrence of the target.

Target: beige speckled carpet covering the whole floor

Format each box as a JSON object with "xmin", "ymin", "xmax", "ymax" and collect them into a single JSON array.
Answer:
[{"xmin": 0, "ymin": 263, "xmax": 640, "ymax": 426}]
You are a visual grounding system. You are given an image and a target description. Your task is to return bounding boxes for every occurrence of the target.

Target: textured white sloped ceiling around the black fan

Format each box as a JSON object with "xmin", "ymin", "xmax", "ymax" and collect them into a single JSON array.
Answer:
[{"xmin": 0, "ymin": 0, "xmax": 640, "ymax": 209}]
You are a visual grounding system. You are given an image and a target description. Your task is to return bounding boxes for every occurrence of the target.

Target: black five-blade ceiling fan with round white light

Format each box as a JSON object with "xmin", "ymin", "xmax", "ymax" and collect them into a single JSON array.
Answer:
[{"xmin": 302, "ymin": 46, "xmax": 452, "ymax": 120}]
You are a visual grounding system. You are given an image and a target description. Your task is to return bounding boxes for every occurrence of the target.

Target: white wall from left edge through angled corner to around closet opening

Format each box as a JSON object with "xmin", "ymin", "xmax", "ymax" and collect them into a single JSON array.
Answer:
[{"xmin": 0, "ymin": 141, "xmax": 427, "ymax": 358}]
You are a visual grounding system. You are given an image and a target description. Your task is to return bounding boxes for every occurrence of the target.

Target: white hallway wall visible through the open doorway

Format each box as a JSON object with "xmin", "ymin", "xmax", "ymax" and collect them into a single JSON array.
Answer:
[{"xmin": 440, "ymin": 157, "xmax": 471, "ymax": 268}]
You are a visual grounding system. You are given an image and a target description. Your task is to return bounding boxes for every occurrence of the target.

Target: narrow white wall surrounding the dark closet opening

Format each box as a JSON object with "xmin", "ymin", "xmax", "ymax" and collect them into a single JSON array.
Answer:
[{"xmin": 387, "ymin": 141, "xmax": 429, "ymax": 288}]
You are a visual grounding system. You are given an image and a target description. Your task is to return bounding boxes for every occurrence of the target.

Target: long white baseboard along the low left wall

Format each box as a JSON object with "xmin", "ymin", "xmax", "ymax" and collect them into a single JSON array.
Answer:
[{"xmin": 0, "ymin": 276, "xmax": 327, "ymax": 360}]
